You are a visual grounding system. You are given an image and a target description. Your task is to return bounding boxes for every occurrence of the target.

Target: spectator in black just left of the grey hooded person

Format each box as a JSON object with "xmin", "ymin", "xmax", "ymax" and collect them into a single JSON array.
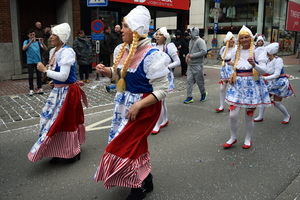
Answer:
[{"xmin": 179, "ymin": 32, "xmax": 191, "ymax": 76}]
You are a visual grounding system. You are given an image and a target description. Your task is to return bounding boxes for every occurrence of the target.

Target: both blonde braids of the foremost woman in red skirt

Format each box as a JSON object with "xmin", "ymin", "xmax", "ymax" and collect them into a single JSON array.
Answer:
[{"xmin": 113, "ymin": 31, "xmax": 140, "ymax": 92}]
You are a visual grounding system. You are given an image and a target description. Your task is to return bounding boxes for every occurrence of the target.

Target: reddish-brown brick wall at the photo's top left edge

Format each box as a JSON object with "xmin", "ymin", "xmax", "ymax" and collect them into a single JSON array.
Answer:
[{"xmin": 0, "ymin": 0, "xmax": 12, "ymax": 43}]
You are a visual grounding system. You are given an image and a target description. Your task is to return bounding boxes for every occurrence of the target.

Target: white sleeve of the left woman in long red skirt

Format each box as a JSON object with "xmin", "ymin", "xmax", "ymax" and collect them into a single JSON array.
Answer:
[{"xmin": 46, "ymin": 48, "xmax": 76, "ymax": 82}]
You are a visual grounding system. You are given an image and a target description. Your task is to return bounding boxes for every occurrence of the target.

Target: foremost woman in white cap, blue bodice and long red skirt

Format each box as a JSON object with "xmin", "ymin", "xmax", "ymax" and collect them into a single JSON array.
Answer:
[{"xmin": 94, "ymin": 5, "xmax": 170, "ymax": 200}]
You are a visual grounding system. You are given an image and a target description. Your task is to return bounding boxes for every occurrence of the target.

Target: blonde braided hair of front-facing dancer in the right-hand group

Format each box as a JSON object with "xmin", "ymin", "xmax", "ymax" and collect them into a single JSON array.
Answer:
[{"xmin": 232, "ymin": 31, "xmax": 259, "ymax": 83}]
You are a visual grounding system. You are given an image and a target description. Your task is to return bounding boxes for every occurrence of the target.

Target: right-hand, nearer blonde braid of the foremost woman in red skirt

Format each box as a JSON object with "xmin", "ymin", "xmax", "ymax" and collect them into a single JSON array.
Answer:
[{"xmin": 117, "ymin": 31, "xmax": 140, "ymax": 92}]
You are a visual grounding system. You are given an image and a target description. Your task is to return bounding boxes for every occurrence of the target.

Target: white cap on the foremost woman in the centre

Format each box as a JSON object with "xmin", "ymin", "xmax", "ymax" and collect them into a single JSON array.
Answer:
[{"xmin": 125, "ymin": 5, "xmax": 151, "ymax": 36}]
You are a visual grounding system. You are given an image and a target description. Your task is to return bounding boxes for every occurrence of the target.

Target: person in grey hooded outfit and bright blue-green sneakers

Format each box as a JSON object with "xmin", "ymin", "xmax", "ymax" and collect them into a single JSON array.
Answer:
[{"xmin": 183, "ymin": 27, "xmax": 208, "ymax": 103}]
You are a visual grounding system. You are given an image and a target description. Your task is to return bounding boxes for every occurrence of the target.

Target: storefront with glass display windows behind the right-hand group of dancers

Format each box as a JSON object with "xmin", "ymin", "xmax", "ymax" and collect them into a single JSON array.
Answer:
[{"xmin": 205, "ymin": 0, "xmax": 300, "ymax": 55}]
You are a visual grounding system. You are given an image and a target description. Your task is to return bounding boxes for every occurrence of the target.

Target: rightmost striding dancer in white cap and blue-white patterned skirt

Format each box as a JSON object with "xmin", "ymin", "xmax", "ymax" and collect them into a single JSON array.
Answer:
[{"xmin": 254, "ymin": 42, "xmax": 294, "ymax": 124}]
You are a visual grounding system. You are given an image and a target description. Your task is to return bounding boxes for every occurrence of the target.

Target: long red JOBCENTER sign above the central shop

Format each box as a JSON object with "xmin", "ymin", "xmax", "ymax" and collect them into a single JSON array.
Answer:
[{"xmin": 109, "ymin": 0, "xmax": 190, "ymax": 10}]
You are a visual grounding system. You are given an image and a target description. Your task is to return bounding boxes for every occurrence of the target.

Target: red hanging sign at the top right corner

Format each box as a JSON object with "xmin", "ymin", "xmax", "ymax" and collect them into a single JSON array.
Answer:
[{"xmin": 286, "ymin": 1, "xmax": 300, "ymax": 31}]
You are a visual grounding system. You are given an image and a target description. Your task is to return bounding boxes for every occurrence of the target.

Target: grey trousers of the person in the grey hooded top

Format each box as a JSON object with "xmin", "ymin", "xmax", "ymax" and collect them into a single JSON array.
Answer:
[{"xmin": 187, "ymin": 65, "xmax": 206, "ymax": 97}]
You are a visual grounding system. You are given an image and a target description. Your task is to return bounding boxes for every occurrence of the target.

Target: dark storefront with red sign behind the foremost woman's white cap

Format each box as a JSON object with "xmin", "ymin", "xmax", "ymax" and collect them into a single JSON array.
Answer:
[{"xmin": 80, "ymin": 0, "xmax": 189, "ymax": 35}]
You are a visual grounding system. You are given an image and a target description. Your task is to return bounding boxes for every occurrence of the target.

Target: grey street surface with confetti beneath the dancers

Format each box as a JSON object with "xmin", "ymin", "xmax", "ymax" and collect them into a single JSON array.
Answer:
[{"xmin": 0, "ymin": 65, "xmax": 300, "ymax": 200}]
